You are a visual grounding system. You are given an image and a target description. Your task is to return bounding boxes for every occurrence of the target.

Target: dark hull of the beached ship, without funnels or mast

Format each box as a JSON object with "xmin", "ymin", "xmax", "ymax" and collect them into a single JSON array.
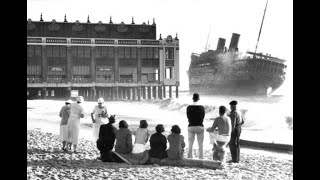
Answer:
[{"xmin": 188, "ymin": 53, "xmax": 285, "ymax": 96}]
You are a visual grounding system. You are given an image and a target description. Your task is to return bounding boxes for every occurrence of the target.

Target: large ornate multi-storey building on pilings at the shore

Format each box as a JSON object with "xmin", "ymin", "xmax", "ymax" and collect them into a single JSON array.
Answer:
[{"xmin": 27, "ymin": 15, "xmax": 179, "ymax": 100}]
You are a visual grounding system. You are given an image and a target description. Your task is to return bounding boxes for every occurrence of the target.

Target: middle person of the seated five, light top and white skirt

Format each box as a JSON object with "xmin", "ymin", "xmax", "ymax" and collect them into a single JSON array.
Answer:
[{"xmin": 132, "ymin": 120, "xmax": 151, "ymax": 154}]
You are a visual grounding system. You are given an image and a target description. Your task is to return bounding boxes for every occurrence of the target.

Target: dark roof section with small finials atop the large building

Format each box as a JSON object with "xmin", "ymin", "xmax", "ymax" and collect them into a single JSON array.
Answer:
[{"xmin": 27, "ymin": 17, "xmax": 156, "ymax": 40}]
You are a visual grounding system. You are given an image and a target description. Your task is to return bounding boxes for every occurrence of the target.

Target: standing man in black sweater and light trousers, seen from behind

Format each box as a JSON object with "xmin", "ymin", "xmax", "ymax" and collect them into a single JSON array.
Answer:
[{"xmin": 187, "ymin": 93, "xmax": 205, "ymax": 159}]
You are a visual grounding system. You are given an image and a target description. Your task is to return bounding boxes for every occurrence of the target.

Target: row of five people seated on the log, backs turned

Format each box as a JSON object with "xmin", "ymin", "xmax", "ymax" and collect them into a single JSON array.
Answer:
[{"xmin": 97, "ymin": 116, "xmax": 185, "ymax": 163}]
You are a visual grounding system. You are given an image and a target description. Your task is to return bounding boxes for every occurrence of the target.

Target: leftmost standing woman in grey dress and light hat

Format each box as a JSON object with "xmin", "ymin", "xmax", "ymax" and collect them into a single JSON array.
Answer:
[{"xmin": 59, "ymin": 99, "xmax": 72, "ymax": 151}]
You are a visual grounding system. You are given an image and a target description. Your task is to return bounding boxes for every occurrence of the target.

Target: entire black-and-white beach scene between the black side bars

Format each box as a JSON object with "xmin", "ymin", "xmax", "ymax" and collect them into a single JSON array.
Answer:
[{"xmin": 26, "ymin": 0, "xmax": 293, "ymax": 180}]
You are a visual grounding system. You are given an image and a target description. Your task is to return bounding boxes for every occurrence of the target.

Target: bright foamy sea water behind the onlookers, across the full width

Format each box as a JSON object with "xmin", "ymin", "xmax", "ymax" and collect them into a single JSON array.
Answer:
[{"xmin": 27, "ymin": 92, "xmax": 293, "ymax": 147}]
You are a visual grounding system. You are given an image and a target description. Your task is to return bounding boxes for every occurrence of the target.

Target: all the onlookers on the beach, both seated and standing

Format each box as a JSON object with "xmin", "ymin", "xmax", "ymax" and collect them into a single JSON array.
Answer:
[{"xmin": 60, "ymin": 93, "xmax": 243, "ymax": 164}]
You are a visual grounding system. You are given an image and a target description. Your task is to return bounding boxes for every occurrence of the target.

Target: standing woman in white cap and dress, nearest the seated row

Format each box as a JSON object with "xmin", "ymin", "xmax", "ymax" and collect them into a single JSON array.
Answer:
[{"xmin": 91, "ymin": 98, "xmax": 109, "ymax": 142}]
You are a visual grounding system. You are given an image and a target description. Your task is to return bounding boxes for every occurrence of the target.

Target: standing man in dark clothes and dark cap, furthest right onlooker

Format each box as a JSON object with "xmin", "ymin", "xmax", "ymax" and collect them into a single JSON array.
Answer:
[{"xmin": 228, "ymin": 101, "xmax": 244, "ymax": 163}]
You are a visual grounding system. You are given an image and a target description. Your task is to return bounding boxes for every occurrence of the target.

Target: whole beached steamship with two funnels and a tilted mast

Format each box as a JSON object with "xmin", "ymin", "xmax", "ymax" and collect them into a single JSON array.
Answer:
[{"xmin": 187, "ymin": 0, "xmax": 287, "ymax": 95}]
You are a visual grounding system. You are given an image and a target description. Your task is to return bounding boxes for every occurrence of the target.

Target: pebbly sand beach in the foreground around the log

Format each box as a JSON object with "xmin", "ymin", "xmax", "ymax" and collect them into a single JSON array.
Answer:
[{"xmin": 27, "ymin": 130, "xmax": 293, "ymax": 180}]
